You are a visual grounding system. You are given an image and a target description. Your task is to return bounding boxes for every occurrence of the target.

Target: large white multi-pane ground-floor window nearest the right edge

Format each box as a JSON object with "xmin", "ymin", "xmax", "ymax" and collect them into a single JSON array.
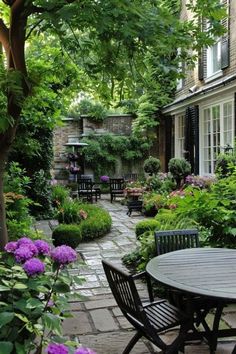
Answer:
[{"xmin": 201, "ymin": 101, "xmax": 234, "ymax": 174}]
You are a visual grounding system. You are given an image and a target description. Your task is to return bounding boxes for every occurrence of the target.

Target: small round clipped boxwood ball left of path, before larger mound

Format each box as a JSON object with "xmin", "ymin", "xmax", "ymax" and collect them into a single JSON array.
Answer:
[{"xmin": 52, "ymin": 224, "xmax": 82, "ymax": 248}]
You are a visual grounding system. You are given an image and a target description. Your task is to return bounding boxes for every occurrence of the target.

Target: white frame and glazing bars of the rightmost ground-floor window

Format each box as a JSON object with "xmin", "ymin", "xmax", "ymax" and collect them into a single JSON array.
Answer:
[{"xmin": 199, "ymin": 96, "xmax": 235, "ymax": 175}]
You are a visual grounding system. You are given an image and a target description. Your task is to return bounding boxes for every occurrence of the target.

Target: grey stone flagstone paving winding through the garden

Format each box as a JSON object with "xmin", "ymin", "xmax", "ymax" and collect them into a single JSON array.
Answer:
[{"xmin": 37, "ymin": 196, "xmax": 236, "ymax": 354}]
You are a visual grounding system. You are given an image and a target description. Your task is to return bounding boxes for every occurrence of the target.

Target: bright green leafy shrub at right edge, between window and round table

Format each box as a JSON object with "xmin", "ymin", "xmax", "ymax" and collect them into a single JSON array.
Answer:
[{"xmin": 170, "ymin": 173, "xmax": 236, "ymax": 248}]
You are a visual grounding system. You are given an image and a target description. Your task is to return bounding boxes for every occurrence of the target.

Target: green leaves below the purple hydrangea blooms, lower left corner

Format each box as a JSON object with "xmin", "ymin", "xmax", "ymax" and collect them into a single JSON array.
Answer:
[{"xmin": 0, "ymin": 236, "xmax": 81, "ymax": 354}]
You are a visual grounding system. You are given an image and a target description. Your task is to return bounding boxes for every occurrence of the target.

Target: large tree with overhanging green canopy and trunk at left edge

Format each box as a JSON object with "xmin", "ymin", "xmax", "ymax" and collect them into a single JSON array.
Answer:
[{"xmin": 0, "ymin": 0, "xmax": 225, "ymax": 247}]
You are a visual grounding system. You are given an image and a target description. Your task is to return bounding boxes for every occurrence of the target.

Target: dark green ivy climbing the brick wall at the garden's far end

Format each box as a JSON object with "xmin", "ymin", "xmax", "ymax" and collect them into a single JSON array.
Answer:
[{"xmin": 82, "ymin": 134, "xmax": 152, "ymax": 178}]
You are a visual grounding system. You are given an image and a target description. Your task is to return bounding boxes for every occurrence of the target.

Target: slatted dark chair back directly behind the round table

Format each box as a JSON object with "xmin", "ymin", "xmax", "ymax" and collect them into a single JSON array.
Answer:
[{"xmin": 155, "ymin": 229, "xmax": 200, "ymax": 256}]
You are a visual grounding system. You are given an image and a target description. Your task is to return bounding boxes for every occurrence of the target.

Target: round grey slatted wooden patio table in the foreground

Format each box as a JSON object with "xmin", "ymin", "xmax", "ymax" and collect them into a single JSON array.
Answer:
[{"xmin": 146, "ymin": 248, "xmax": 236, "ymax": 353}]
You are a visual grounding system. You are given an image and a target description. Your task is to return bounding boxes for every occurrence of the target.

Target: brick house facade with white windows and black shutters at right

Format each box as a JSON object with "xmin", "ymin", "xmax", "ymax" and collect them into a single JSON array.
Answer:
[{"xmin": 162, "ymin": 0, "xmax": 236, "ymax": 175}]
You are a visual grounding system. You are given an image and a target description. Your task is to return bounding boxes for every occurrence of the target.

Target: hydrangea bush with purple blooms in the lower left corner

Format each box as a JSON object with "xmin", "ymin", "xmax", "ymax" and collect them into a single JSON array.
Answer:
[{"xmin": 0, "ymin": 237, "xmax": 95, "ymax": 354}]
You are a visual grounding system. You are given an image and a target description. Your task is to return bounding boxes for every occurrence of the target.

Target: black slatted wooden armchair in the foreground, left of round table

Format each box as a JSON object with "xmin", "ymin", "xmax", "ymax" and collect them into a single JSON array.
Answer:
[{"xmin": 102, "ymin": 260, "xmax": 189, "ymax": 354}]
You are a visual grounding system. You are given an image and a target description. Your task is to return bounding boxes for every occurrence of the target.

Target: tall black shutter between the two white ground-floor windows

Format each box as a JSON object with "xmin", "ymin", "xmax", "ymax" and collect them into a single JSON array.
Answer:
[{"xmin": 184, "ymin": 106, "xmax": 199, "ymax": 174}]
